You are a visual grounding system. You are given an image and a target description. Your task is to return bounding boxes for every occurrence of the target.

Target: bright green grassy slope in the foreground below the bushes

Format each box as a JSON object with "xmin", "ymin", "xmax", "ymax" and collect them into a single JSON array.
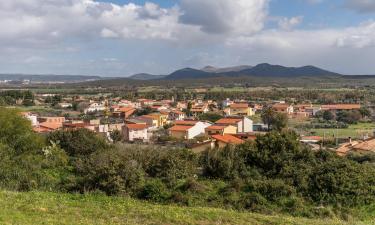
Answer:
[{"xmin": 0, "ymin": 191, "xmax": 372, "ymax": 225}]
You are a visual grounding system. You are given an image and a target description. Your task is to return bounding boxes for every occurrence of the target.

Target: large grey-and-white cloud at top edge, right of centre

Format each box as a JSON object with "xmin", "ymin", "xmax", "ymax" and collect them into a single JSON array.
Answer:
[{"xmin": 180, "ymin": 0, "xmax": 269, "ymax": 34}]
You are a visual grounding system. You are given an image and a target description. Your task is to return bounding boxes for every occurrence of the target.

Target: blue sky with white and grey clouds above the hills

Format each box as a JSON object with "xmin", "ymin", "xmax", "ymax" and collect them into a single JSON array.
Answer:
[{"xmin": 0, "ymin": 0, "xmax": 375, "ymax": 77}]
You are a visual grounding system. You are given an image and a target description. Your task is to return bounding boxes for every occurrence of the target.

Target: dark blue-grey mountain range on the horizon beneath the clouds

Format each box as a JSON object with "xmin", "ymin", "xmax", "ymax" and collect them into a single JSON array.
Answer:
[{"xmin": 129, "ymin": 63, "xmax": 341, "ymax": 80}]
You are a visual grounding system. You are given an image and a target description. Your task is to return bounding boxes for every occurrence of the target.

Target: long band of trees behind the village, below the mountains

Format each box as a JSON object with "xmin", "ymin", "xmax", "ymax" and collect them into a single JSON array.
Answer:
[{"xmin": 113, "ymin": 88, "xmax": 375, "ymax": 104}]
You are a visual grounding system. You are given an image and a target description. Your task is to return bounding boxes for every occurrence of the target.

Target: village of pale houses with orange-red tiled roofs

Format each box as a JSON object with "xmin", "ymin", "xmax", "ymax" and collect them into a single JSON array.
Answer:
[{"xmin": 18, "ymin": 94, "xmax": 375, "ymax": 155}]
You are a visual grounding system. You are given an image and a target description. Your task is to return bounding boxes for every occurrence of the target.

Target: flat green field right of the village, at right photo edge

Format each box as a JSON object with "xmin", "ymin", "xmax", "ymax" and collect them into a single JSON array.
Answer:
[{"xmin": 311, "ymin": 123, "xmax": 375, "ymax": 138}]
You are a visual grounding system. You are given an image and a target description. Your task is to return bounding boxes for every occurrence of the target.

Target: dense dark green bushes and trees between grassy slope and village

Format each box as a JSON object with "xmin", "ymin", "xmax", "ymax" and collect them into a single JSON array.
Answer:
[{"xmin": 0, "ymin": 109, "xmax": 375, "ymax": 218}]
